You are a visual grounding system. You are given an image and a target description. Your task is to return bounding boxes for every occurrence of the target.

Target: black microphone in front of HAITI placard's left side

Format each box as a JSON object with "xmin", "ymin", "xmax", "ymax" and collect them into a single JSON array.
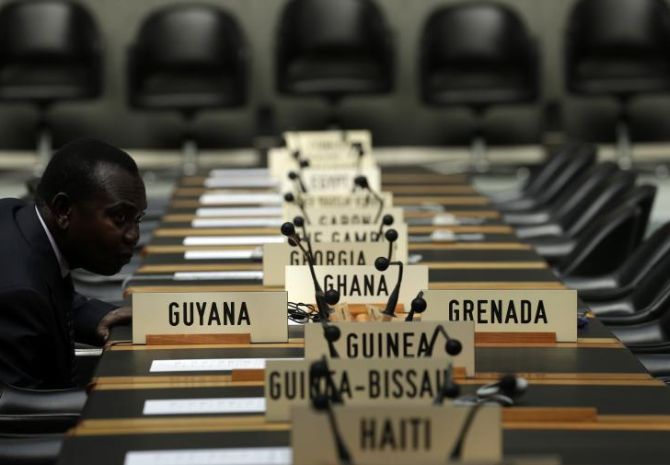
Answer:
[{"xmin": 309, "ymin": 357, "xmax": 353, "ymax": 465}]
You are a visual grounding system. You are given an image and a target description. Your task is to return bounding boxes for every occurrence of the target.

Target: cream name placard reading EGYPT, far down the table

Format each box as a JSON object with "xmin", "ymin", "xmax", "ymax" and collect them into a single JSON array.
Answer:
[{"xmin": 282, "ymin": 167, "xmax": 381, "ymax": 194}]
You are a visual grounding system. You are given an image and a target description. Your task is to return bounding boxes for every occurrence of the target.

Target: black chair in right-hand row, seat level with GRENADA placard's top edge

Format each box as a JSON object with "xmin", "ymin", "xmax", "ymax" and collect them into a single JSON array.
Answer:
[{"xmin": 561, "ymin": 222, "xmax": 670, "ymax": 303}]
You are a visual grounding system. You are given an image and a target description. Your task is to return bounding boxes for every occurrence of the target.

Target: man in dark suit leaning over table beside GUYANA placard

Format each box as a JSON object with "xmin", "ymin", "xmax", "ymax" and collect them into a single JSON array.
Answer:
[{"xmin": 0, "ymin": 139, "xmax": 146, "ymax": 388}]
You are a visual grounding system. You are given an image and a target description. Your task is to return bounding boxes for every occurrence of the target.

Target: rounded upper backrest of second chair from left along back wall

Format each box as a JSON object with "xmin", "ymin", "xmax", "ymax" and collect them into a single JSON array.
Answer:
[{"xmin": 133, "ymin": 4, "xmax": 244, "ymax": 74}]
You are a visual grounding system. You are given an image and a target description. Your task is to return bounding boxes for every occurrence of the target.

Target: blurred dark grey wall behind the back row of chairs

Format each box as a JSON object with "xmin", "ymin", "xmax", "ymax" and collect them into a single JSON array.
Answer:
[{"xmin": 0, "ymin": 0, "xmax": 670, "ymax": 149}]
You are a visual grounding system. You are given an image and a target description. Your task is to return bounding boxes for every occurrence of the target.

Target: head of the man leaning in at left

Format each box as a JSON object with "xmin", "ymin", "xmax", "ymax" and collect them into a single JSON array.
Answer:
[{"xmin": 37, "ymin": 139, "xmax": 146, "ymax": 275}]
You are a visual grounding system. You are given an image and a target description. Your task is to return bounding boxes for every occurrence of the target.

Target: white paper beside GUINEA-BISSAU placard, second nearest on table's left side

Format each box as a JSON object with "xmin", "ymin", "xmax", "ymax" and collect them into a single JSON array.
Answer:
[{"xmin": 142, "ymin": 397, "xmax": 265, "ymax": 415}]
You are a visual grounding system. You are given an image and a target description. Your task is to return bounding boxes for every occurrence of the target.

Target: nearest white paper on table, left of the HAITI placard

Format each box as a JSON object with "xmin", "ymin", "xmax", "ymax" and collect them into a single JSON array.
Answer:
[{"xmin": 123, "ymin": 447, "xmax": 293, "ymax": 465}]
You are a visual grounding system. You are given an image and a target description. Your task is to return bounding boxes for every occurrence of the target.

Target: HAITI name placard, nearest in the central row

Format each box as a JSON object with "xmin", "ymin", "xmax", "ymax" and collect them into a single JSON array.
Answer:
[{"xmin": 291, "ymin": 403, "xmax": 503, "ymax": 465}]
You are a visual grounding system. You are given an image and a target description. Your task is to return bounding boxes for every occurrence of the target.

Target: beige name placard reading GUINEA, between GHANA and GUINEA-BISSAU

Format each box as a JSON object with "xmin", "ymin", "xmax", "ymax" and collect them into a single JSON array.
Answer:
[{"xmin": 305, "ymin": 318, "xmax": 475, "ymax": 376}]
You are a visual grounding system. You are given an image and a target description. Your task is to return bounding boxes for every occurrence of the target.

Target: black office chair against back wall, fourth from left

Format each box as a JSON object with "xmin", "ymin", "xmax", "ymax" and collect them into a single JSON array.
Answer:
[{"xmin": 419, "ymin": 2, "xmax": 539, "ymax": 171}]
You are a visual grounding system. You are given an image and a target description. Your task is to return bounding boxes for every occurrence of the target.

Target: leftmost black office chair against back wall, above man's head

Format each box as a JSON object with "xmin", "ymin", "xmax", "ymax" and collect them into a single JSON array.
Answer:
[{"xmin": 0, "ymin": 0, "xmax": 102, "ymax": 175}]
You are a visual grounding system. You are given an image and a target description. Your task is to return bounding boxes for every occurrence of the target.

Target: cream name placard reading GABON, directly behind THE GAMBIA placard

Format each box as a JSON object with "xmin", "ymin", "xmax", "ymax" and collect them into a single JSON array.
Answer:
[{"xmin": 284, "ymin": 208, "xmax": 405, "ymax": 227}]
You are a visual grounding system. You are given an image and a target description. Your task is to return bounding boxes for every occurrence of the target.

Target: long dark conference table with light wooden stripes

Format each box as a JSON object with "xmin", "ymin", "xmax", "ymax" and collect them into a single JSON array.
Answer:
[{"xmin": 59, "ymin": 167, "xmax": 670, "ymax": 465}]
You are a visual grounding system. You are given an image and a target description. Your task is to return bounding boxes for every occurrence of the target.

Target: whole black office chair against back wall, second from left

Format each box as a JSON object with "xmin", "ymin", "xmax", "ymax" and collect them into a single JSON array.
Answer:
[{"xmin": 127, "ymin": 4, "xmax": 247, "ymax": 173}]
